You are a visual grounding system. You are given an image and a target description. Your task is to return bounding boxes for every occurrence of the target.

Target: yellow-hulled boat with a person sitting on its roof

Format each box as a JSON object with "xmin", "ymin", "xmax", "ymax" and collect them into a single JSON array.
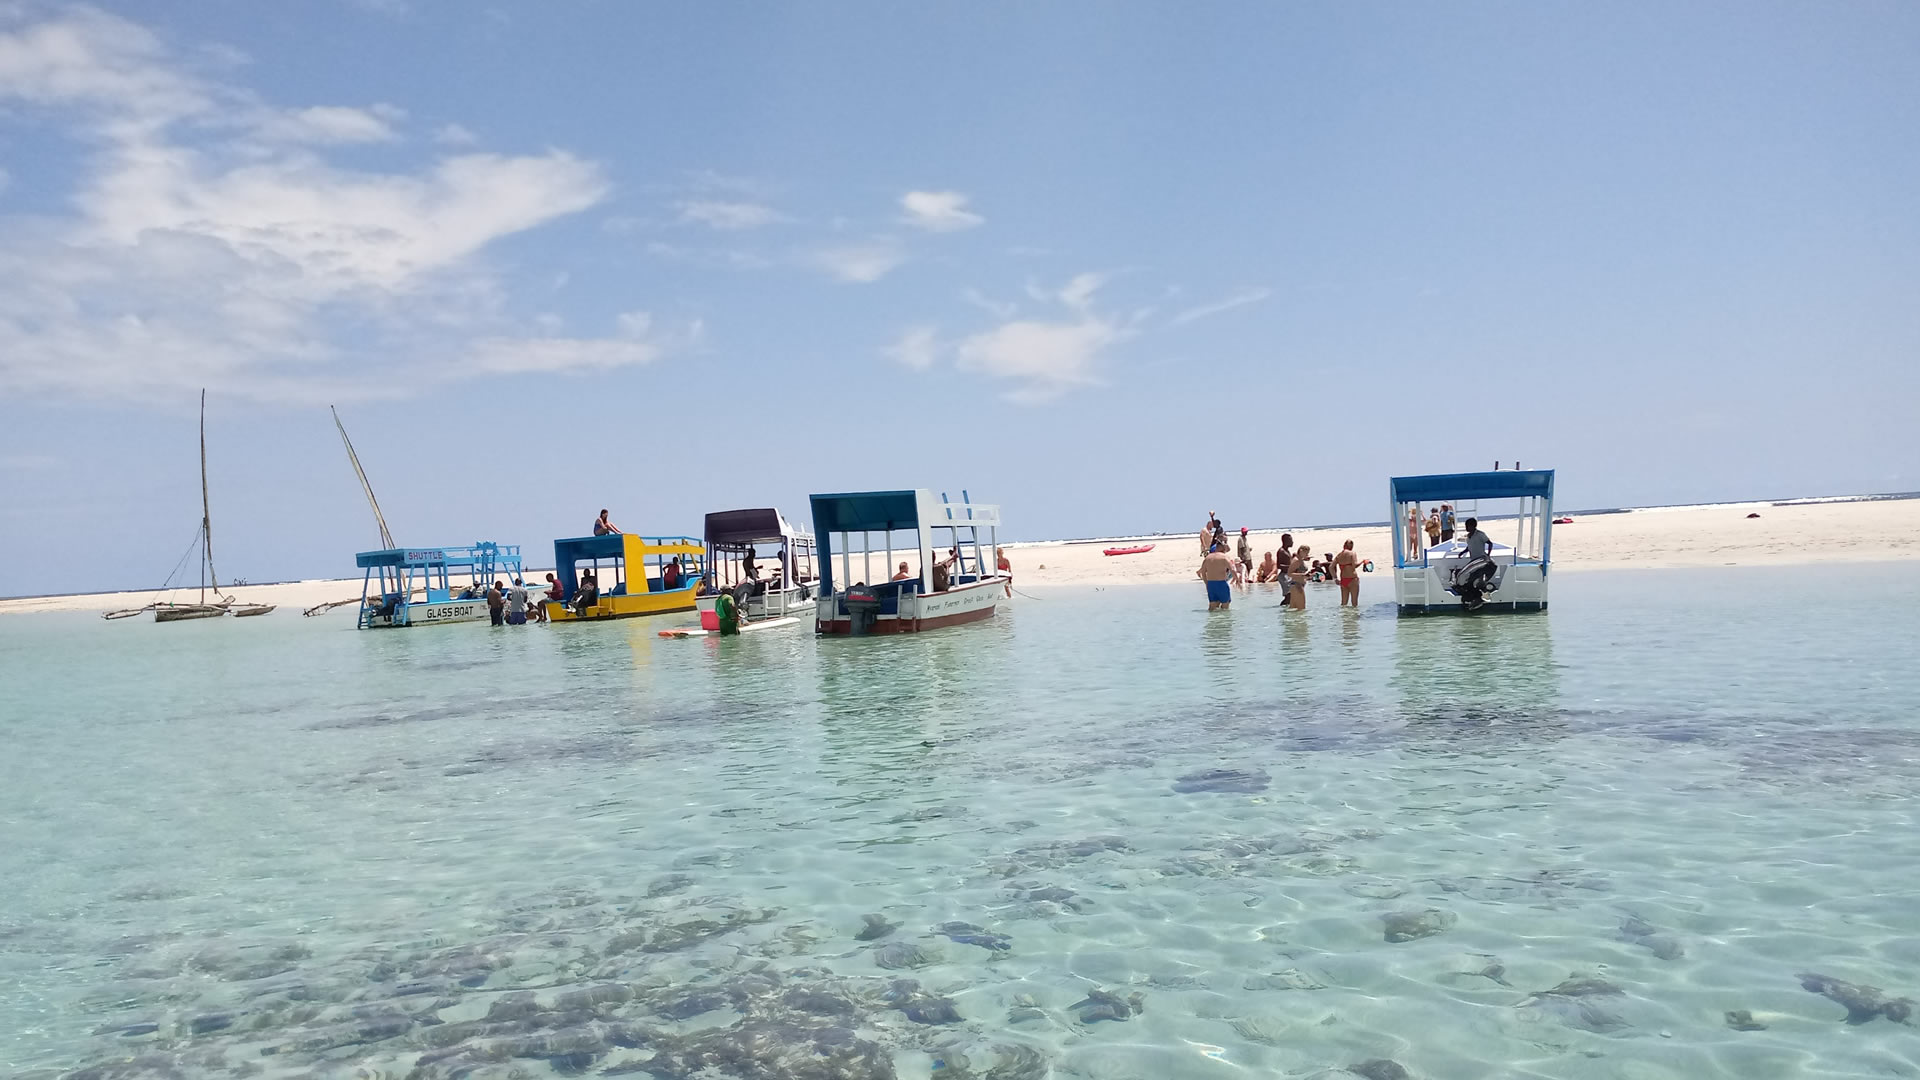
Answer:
[{"xmin": 543, "ymin": 532, "xmax": 707, "ymax": 623}]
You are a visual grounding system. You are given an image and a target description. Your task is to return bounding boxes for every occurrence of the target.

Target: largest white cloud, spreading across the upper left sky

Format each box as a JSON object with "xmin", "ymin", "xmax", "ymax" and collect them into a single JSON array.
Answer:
[{"xmin": 0, "ymin": 4, "xmax": 660, "ymax": 400}]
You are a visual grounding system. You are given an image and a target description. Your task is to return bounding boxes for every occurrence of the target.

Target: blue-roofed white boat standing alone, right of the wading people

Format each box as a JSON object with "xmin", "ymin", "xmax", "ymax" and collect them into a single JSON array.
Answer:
[{"xmin": 1388, "ymin": 469, "xmax": 1553, "ymax": 615}]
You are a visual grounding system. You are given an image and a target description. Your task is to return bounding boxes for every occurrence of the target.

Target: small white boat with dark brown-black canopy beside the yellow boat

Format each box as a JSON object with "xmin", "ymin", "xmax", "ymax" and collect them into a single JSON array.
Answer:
[{"xmin": 697, "ymin": 507, "xmax": 820, "ymax": 630}]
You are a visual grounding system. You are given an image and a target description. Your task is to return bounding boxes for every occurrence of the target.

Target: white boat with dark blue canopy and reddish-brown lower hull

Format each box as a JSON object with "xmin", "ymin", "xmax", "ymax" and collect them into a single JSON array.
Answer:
[{"xmin": 810, "ymin": 488, "xmax": 1008, "ymax": 634}]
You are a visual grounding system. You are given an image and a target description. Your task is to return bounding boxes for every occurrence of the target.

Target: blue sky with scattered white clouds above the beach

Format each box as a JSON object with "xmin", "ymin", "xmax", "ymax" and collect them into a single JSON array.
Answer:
[{"xmin": 0, "ymin": 0, "xmax": 1920, "ymax": 596}]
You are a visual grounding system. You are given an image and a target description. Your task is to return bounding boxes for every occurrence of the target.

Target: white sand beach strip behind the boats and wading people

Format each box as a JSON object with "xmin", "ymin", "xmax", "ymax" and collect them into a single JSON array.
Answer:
[{"xmin": 0, "ymin": 500, "xmax": 1920, "ymax": 615}]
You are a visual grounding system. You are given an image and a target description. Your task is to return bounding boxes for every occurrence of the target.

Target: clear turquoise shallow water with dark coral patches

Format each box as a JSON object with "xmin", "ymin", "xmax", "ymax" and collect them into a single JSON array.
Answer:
[{"xmin": 0, "ymin": 565, "xmax": 1920, "ymax": 1080}]
